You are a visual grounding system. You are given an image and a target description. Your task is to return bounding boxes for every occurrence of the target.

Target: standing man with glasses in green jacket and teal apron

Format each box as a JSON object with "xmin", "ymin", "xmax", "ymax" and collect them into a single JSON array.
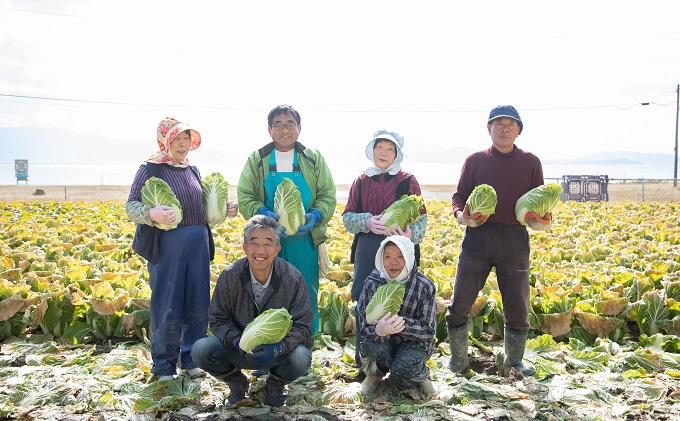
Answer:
[{"xmin": 237, "ymin": 105, "xmax": 337, "ymax": 338}]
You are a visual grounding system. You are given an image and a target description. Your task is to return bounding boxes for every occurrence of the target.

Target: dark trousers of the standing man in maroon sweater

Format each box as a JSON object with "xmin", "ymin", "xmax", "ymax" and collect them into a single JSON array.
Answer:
[{"xmin": 446, "ymin": 224, "xmax": 530, "ymax": 331}]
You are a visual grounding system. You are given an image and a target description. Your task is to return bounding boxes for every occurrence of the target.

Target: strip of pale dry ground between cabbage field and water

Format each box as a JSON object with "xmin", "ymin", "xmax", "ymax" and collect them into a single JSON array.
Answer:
[{"xmin": 0, "ymin": 182, "xmax": 680, "ymax": 204}]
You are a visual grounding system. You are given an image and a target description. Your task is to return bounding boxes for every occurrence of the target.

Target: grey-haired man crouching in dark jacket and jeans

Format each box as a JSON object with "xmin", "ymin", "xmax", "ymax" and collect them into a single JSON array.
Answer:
[{"xmin": 191, "ymin": 215, "xmax": 312, "ymax": 406}]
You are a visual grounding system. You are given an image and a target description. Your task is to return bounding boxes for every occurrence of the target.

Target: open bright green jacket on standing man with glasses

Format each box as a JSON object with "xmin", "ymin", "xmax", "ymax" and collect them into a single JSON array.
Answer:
[{"xmin": 236, "ymin": 142, "xmax": 337, "ymax": 247}]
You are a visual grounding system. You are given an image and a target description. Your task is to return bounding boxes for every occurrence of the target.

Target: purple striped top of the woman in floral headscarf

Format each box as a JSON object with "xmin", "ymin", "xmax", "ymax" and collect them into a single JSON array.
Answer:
[{"xmin": 128, "ymin": 164, "xmax": 206, "ymax": 227}]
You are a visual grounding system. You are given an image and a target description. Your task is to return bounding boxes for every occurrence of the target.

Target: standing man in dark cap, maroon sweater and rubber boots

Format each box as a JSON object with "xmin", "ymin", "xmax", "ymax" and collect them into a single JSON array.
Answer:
[{"xmin": 446, "ymin": 105, "xmax": 552, "ymax": 376}]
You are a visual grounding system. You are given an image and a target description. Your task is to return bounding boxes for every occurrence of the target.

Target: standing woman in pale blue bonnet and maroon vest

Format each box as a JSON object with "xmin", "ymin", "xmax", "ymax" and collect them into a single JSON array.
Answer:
[{"xmin": 342, "ymin": 130, "xmax": 427, "ymax": 366}]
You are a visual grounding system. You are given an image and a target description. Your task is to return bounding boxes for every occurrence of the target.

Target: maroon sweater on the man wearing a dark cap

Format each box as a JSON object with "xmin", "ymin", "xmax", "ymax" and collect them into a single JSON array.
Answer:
[{"xmin": 451, "ymin": 146, "xmax": 544, "ymax": 225}]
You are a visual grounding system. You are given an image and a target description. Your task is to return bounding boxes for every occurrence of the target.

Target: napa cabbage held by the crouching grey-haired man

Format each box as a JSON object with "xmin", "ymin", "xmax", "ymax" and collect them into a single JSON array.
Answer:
[{"xmin": 238, "ymin": 308, "xmax": 293, "ymax": 353}]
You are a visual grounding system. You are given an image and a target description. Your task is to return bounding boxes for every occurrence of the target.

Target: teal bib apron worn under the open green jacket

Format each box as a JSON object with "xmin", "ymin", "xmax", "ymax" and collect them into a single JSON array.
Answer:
[{"xmin": 264, "ymin": 151, "xmax": 319, "ymax": 337}]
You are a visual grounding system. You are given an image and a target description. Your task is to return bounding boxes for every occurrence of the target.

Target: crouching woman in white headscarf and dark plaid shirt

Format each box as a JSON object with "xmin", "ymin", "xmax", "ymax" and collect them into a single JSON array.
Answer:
[{"xmin": 357, "ymin": 235, "xmax": 437, "ymax": 395}]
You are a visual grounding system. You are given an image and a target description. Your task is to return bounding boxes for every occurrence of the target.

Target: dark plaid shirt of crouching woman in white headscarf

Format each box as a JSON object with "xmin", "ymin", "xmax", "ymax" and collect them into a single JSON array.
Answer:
[{"xmin": 357, "ymin": 267, "xmax": 437, "ymax": 355}]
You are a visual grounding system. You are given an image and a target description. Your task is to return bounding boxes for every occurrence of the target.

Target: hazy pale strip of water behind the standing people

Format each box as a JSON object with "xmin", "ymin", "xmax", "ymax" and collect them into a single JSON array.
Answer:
[{"xmin": 0, "ymin": 162, "xmax": 674, "ymax": 186}]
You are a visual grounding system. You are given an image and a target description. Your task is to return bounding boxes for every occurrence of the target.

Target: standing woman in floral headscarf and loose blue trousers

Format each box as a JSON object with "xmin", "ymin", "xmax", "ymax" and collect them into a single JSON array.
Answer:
[{"xmin": 125, "ymin": 117, "xmax": 238, "ymax": 380}]
